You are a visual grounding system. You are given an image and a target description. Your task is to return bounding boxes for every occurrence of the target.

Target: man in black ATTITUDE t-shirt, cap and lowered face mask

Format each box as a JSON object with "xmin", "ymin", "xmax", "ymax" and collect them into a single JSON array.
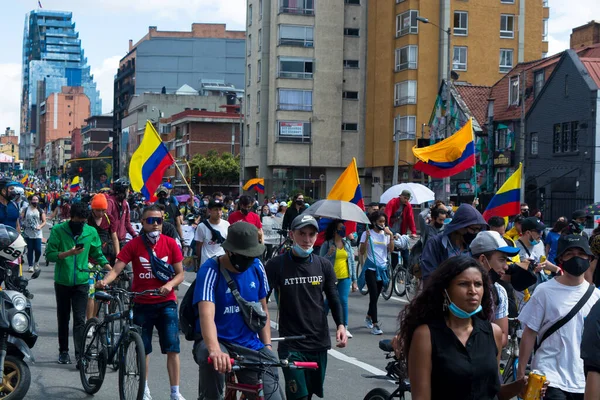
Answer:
[{"xmin": 266, "ymin": 215, "xmax": 348, "ymax": 400}]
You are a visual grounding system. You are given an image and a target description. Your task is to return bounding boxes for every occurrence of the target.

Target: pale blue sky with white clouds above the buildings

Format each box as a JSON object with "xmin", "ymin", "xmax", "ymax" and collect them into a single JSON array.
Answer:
[{"xmin": 0, "ymin": 0, "xmax": 600, "ymax": 138}]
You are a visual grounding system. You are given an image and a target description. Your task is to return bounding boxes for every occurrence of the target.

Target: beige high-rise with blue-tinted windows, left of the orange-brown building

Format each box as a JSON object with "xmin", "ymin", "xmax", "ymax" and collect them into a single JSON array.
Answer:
[{"xmin": 241, "ymin": 0, "xmax": 366, "ymax": 198}]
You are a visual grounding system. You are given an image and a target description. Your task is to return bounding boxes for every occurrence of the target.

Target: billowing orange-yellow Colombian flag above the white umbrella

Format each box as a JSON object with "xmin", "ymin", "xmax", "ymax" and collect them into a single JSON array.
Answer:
[{"xmin": 413, "ymin": 118, "xmax": 475, "ymax": 178}]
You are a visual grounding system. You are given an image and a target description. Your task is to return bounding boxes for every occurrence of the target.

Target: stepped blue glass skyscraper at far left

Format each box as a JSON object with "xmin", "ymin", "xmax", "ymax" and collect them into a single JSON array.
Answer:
[{"xmin": 19, "ymin": 9, "xmax": 102, "ymax": 166}]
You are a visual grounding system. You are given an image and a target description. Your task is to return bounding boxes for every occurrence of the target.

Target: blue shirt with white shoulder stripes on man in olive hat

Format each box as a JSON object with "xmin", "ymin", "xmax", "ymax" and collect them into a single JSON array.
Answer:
[{"xmin": 193, "ymin": 258, "xmax": 269, "ymax": 350}]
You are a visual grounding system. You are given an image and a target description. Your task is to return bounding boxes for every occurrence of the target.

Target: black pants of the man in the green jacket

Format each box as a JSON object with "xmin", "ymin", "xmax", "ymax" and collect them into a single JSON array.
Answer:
[{"xmin": 54, "ymin": 282, "xmax": 89, "ymax": 358}]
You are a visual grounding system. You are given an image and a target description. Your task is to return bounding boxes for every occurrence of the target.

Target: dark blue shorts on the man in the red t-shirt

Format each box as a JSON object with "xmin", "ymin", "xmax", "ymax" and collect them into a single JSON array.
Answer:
[{"xmin": 133, "ymin": 301, "xmax": 179, "ymax": 354}]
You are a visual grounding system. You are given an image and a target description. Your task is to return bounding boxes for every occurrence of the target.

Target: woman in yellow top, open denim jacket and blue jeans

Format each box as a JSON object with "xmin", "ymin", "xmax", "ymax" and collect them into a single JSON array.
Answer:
[{"xmin": 320, "ymin": 219, "xmax": 358, "ymax": 338}]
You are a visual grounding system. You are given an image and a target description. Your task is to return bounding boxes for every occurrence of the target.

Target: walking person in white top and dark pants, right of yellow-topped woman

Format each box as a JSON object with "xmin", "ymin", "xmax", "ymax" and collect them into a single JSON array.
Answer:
[{"xmin": 359, "ymin": 211, "xmax": 394, "ymax": 335}]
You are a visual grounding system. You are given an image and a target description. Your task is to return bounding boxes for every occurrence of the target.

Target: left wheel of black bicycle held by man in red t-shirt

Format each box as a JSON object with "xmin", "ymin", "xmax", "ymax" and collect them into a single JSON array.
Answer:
[{"xmin": 78, "ymin": 318, "xmax": 108, "ymax": 394}]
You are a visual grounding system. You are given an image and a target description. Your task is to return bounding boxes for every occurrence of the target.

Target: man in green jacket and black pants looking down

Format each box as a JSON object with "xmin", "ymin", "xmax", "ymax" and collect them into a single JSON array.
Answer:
[{"xmin": 46, "ymin": 203, "xmax": 111, "ymax": 364}]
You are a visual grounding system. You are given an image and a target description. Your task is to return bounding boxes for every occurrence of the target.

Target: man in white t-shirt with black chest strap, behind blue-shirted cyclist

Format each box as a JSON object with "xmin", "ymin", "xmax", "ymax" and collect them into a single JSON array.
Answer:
[{"xmin": 194, "ymin": 199, "xmax": 229, "ymax": 265}]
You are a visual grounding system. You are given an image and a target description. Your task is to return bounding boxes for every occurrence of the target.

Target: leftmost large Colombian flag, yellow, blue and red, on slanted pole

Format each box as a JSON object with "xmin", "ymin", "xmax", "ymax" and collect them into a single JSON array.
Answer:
[{"xmin": 129, "ymin": 121, "xmax": 175, "ymax": 201}]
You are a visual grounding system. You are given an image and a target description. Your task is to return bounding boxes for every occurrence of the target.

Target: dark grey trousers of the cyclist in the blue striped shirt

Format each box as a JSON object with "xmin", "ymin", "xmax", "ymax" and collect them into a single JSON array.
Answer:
[{"xmin": 193, "ymin": 341, "xmax": 284, "ymax": 400}]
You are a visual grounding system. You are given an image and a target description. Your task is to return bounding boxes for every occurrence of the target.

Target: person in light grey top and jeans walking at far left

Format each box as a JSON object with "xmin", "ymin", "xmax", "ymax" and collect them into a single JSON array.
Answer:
[{"xmin": 21, "ymin": 195, "xmax": 46, "ymax": 272}]
